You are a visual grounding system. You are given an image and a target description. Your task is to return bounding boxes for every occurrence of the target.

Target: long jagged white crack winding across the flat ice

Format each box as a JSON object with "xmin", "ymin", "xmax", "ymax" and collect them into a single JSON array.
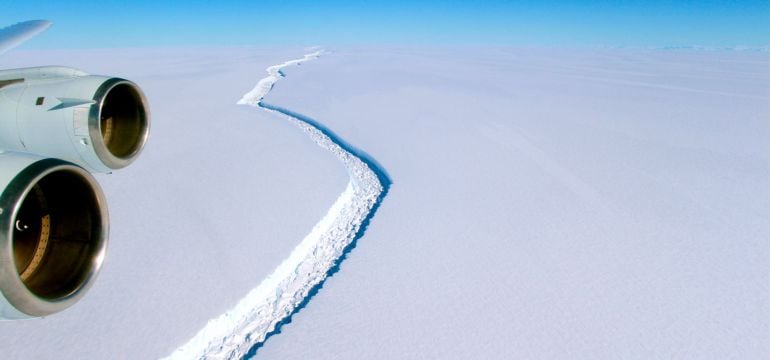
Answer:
[{"xmin": 168, "ymin": 50, "xmax": 384, "ymax": 359}]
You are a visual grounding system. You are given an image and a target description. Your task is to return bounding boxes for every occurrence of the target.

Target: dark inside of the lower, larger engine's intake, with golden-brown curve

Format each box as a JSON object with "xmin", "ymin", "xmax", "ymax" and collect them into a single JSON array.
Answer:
[{"xmin": 11, "ymin": 170, "xmax": 106, "ymax": 300}]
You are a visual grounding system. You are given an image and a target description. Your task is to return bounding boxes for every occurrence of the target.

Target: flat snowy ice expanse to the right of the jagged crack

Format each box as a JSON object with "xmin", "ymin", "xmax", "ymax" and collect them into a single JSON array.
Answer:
[{"xmin": 256, "ymin": 48, "xmax": 770, "ymax": 359}]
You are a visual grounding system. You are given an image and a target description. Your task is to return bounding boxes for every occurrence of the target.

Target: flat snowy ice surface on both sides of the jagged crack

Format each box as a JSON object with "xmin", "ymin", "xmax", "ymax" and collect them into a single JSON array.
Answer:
[{"xmin": 0, "ymin": 47, "xmax": 770, "ymax": 359}]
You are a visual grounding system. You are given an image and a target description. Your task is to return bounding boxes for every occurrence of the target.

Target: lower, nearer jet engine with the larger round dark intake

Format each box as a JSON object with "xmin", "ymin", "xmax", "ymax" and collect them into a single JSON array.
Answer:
[{"xmin": 0, "ymin": 153, "xmax": 109, "ymax": 319}]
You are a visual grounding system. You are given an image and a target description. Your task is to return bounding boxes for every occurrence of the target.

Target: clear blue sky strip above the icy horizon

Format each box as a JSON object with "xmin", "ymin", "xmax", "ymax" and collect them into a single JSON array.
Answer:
[{"xmin": 0, "ymin": 0, "xmax": 770, "ymax": 48}]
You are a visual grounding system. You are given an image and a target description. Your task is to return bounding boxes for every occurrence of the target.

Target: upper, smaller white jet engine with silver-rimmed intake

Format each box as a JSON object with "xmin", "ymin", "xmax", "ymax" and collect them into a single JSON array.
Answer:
[{"xmin": 0, "ymin": 66, "xmax": 150, "ymax": 172}]
